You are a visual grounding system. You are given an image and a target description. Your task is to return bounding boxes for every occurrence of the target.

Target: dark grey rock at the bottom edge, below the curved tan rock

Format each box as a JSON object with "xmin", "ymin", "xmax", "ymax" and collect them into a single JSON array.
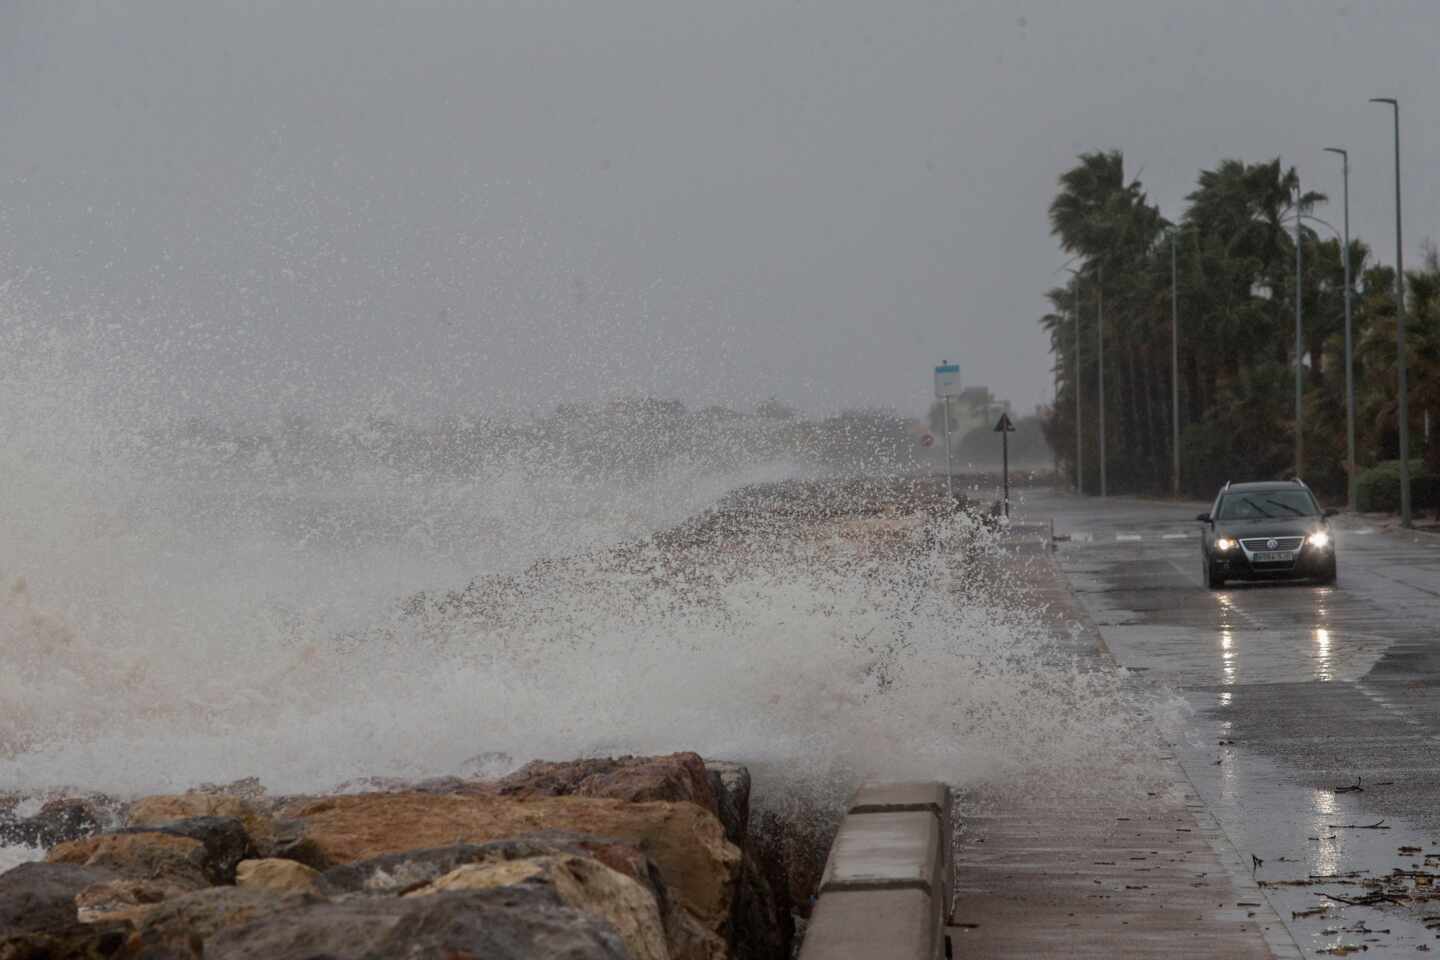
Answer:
[{"xmin": 204, "ymin": 885, "xmax": 626, "ymax": 960}]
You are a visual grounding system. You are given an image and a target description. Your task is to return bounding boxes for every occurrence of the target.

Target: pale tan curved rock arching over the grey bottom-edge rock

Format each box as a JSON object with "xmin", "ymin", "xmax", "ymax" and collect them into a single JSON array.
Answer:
[{"xmin": 406, "ymin": 855, "xmax": 670, "ymax": 960}]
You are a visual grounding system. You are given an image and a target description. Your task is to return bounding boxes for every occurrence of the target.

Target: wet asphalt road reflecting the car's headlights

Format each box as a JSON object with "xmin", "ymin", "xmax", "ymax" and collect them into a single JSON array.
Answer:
[{"xmin": 1015, "ymin": 491, "xmax": 1440, "ymax": 956}]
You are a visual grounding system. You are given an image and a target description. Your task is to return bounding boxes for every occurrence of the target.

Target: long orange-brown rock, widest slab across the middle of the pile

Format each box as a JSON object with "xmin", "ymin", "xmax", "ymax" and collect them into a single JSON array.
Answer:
[{"xmin": 276, "ymin": 793, "xmax": 740, "ymax": 936}]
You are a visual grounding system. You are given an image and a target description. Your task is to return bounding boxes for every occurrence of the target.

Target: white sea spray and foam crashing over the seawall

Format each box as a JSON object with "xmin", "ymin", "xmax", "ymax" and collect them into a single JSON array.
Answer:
[{"xmin": 0, "ymin": 296, "xmax": 1152, "ymax": 793}]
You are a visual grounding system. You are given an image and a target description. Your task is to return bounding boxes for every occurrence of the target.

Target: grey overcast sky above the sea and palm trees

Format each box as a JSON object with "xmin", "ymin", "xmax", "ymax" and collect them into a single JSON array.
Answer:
[{"xmin": 0, "ymin": 0, "xmax": 1440, "ymax": 413}]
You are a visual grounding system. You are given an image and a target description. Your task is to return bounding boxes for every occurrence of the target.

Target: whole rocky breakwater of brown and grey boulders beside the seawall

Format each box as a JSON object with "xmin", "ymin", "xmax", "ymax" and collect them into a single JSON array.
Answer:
[{"xmin": 0, "ymin": 753, "xmax": 792, "ymax": 960}]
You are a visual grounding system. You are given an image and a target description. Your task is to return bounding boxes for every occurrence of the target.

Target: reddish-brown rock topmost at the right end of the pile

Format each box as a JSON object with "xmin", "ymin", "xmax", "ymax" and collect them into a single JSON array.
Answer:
[{"xmin": 495, "ymin": 753, "xmax": 719, "ymax": 815}]
